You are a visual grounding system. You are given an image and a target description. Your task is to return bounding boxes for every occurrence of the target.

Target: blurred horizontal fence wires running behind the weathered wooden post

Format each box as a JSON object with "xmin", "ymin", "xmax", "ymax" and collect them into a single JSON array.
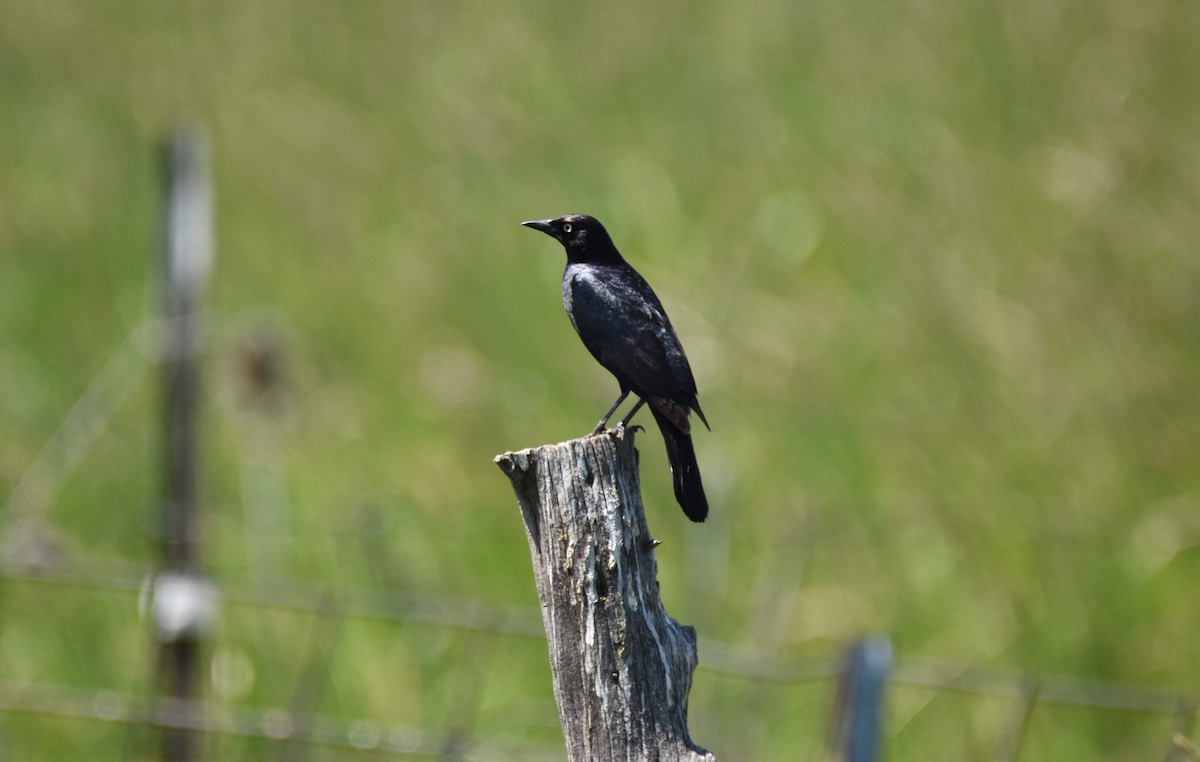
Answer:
[{"xmin": 0, "ymin": 552, "xmax": 1200, "ymax": 760}]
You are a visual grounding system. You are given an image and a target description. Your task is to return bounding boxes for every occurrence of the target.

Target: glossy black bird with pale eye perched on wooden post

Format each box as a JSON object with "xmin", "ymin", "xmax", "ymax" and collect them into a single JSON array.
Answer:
[{"xmin": 521, "ymin": 215, "xmax": 708, "ymax": 521}]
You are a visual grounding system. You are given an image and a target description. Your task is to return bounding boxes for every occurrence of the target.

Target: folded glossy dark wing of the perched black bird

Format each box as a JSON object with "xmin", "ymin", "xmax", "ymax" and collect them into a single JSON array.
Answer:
[{"xmin": 569, "ymin": 268, "xmax": 696, "ymax": 422}]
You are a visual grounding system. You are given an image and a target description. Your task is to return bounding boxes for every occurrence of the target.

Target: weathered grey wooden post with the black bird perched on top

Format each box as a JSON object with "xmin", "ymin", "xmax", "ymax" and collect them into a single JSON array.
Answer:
[{"xmin": 496, "ymin": 430, "xmax": 715, "ymax": 762}]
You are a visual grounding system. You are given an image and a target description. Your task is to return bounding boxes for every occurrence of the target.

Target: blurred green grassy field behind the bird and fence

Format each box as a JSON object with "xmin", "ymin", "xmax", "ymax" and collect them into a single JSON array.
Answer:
[{"xmin": 0, "ymin": 0, "xmax": 1200, "ymax": 760}]
